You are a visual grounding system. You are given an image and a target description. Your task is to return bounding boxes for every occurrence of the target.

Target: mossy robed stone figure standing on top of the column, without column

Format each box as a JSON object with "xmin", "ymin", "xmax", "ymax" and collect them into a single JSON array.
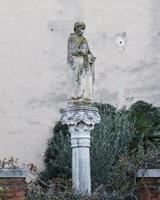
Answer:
[{"xmin": 67, "ymin": 22, "xmax": 96, "ymax": 102}]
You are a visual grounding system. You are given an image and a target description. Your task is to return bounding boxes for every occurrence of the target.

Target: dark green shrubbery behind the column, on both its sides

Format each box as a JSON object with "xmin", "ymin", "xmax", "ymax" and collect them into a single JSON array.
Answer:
[{"xmin": 35, "ymin": 101, "xmax": 160, "ymax": 199}]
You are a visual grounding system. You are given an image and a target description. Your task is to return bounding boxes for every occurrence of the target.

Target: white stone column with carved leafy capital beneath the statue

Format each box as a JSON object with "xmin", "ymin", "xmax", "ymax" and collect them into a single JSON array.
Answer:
[{"xmin": 61, "ymin": 105, "xmax": 100, "ymax": 195}]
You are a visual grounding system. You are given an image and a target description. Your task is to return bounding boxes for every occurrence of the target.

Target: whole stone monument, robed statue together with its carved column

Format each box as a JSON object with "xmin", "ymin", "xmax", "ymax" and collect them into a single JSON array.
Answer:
[{"xmin": 60, "ymin": 22, "xmax": 100, "ymax": 196}]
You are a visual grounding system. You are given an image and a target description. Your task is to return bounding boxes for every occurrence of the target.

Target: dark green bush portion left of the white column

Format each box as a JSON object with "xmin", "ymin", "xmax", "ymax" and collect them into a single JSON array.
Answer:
[{"xmin": 40, "ymin": 122, "xmax": 72, "ymax": 179}]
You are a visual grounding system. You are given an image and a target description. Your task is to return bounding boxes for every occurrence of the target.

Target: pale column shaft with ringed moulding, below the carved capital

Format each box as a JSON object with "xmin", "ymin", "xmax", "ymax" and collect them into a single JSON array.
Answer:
[{"xmin": 71, "ymin": 136, "xmax": 91, "ymax": 195}]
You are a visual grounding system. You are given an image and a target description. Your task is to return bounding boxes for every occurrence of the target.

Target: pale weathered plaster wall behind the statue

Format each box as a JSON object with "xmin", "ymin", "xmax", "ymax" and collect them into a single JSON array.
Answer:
[{"xmin": 0, "ymin": 0, "xmax": 160, "ymax": 169}]
